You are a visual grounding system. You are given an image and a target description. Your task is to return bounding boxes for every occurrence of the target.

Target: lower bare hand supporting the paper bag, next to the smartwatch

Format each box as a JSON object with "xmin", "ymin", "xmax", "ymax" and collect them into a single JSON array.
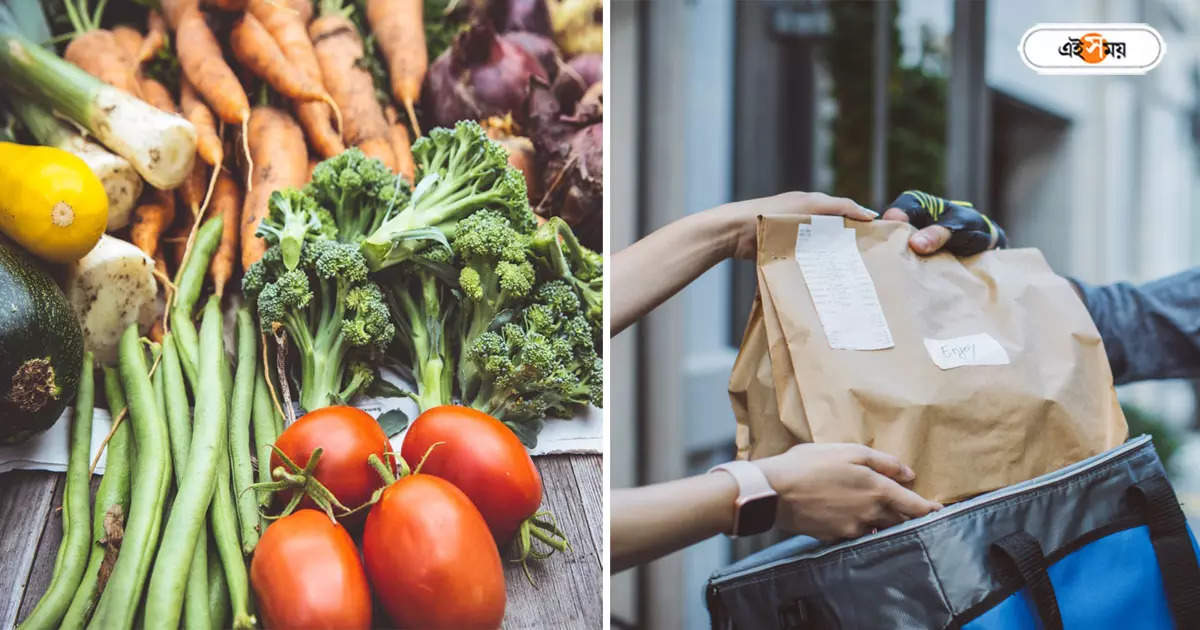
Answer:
[{"xmin": 755, "ymin": 444, "xmax": 942, "ymax": 540}]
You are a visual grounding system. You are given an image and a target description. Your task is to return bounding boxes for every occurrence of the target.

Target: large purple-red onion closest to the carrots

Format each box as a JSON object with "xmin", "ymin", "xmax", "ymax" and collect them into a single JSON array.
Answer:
[{"xmin": 425, "ymin": 19, "xmax": 547, "ymax": 127}]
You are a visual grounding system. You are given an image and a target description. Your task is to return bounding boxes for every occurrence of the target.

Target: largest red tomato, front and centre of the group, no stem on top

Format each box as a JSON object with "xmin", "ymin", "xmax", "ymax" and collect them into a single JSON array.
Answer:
[{"xmin": 362, "ymin": 474, "xmax": 504, "ymax": 630}]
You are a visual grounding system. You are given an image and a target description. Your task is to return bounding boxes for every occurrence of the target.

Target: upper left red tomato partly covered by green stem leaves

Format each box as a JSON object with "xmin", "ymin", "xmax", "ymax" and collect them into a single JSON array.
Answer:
[{"xmin": 271, "ymin": 407, "xmax": 391, "ymax": 518}]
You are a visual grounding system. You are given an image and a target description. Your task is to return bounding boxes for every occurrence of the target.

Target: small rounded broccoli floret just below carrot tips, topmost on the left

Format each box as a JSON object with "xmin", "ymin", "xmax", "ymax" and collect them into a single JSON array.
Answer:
[{"xmin": 304, "ymin": 148, "xmax": 409, "ymax": 244}]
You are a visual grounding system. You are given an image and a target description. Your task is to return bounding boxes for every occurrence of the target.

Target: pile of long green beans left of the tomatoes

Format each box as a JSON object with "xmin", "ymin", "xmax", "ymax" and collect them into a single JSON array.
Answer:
[{"xmin": 19, "ymin": 217, "xmax": 283, "ymax": 630}]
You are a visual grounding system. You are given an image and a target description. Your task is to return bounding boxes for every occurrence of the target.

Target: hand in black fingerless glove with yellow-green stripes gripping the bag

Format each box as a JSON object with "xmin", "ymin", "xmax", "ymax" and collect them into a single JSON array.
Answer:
[{"xmin": 881, "ymin": 191, "xmax": 1007, "ymax": 256}]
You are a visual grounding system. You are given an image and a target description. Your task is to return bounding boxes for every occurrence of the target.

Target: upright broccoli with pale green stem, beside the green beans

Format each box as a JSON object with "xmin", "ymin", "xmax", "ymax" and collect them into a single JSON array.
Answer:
[{"xmin": 242, "ymin": 239, "xmax": 396, "ymax": 409}]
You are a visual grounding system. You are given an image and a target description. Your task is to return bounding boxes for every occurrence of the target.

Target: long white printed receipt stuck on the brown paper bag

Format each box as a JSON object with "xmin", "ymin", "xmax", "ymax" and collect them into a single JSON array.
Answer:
[{"xmin": 796, "ymin": 216, "xmax": 895, "ymax": 350}]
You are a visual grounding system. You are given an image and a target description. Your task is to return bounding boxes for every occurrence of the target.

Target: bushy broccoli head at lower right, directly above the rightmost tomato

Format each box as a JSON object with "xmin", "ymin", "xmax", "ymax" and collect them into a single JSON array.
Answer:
[{"xmin": 467, "ymin": 280, "xmax": 604, "ymax": 448}]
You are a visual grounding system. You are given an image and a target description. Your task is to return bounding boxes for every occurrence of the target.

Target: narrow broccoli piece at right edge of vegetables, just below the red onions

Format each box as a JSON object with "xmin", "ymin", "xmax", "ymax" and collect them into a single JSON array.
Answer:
[{"xmin": 529, "ymin": 216, "xmax": 604, "ymax": 340}]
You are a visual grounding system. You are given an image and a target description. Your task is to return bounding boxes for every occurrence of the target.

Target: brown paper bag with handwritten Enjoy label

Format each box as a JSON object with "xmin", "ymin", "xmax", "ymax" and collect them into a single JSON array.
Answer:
[{"xmin": 730, "ymin": 216, "xmax": 1128, "ymax": 503}]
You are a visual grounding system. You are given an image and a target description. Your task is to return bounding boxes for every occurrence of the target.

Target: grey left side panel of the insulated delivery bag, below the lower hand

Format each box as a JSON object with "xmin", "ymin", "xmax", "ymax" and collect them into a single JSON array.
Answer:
[{"xmin": 718, "ymin": 533, "xmax": 950, "ymax": 630}]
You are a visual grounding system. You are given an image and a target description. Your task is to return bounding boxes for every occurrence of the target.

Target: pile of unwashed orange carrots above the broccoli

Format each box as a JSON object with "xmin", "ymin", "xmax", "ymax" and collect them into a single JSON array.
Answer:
[{"xmin": 56, "ymin": 0, "xmax": 427, "ymax": 314}]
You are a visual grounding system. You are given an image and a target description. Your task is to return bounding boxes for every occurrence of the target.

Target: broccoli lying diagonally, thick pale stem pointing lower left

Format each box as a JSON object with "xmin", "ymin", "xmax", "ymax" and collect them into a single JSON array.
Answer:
[{"xmin": 350, "ymin": 120, "xmax": 534, "ymax": 271}]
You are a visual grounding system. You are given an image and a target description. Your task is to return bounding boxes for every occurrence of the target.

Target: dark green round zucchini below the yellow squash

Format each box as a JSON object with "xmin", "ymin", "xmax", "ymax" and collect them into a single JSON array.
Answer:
[{"xmin": 0, "ymin": 231, "xmax": 83, "ymax": 444}]
